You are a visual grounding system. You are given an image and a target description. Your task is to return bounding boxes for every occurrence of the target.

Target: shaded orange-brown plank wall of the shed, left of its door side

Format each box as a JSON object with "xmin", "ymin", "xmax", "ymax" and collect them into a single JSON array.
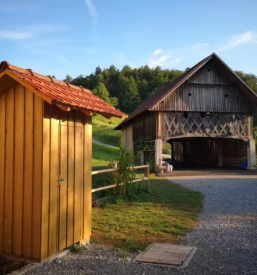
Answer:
[{"xmin": 0, "ymin": 84, "xmax": 43, "ymax": 258}]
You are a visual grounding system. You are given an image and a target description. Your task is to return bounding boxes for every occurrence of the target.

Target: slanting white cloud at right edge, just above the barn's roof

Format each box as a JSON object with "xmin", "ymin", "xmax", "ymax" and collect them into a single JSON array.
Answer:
[{"xmin": 219, "ymin": 31, "xmax": 257, "ymax": 51}]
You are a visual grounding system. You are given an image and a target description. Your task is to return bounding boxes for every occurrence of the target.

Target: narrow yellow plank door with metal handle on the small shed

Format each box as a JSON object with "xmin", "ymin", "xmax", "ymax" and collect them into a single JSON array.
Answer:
[{"xmin": 57, "ymin": 124, "xmax": 83, "ymax": 251}]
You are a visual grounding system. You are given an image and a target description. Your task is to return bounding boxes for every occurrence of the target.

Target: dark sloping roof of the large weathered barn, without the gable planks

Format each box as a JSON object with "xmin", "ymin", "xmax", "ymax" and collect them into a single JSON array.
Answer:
[{"xmin": 115, "ymin": 53, "xmax": 257, "ymax": 130}]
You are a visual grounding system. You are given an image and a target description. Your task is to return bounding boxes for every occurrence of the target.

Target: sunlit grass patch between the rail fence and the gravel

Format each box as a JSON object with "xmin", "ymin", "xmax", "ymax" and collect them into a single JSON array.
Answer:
[{"xmin": 91, "ymin": 177, "xmax": 203, "ymax": 252}]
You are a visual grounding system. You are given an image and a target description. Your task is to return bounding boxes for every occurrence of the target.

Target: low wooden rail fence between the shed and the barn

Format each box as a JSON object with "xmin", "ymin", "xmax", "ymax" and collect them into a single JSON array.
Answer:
[{"xmin": 92, "ymin": 164, "xmax": 150, "ymax": 193}]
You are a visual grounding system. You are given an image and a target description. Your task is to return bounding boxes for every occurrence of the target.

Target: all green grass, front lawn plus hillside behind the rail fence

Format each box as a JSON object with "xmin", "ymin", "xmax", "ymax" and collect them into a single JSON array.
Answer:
[{"xmin": 91, "ymin": 116, "xmax": 203, "ymax": 251}]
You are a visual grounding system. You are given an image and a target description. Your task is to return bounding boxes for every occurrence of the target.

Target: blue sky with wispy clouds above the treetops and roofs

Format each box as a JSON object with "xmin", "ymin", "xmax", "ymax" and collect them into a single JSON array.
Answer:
[{"xmin": 0, "ymin": 0, "xmax": 257, "ymax": 79}]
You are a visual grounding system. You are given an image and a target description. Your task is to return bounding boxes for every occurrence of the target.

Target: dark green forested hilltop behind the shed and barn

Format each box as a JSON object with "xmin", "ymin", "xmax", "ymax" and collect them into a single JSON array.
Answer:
[{"xmin": 65, "ymin": 65, "xmax": 257, "ymax": 124}]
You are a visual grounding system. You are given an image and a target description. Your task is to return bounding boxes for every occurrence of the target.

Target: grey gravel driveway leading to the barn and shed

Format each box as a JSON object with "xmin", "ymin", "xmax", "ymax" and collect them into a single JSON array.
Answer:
[{"xmin": 27, "ymin": 176, "xmax": 257, "ymax": 275}]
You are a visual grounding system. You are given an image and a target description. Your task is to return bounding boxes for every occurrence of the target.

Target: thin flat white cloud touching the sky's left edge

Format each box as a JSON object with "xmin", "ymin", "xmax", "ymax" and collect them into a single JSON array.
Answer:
[{"xmin": 0, "ymin": 25, "xmax": 63, "ymax": 40}]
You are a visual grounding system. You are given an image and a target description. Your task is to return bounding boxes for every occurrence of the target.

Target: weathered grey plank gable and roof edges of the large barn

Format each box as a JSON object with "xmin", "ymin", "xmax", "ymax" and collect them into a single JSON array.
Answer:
[{"xmin": 116, "ymin": 53, "xmax": 257, "ymax": 130}]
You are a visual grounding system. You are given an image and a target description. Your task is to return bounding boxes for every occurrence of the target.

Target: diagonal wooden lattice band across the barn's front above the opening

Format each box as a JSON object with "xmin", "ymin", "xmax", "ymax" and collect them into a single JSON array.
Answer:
[{"xmin": 161, "ymin": 112, "xmax": 253, "ymax": 140}]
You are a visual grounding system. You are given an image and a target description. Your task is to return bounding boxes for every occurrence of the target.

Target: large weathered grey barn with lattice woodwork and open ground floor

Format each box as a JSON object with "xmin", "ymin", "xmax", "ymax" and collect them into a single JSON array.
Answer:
[{"xmin": 116, "ymin": 53, "xmax": 257, "ymax": 169}]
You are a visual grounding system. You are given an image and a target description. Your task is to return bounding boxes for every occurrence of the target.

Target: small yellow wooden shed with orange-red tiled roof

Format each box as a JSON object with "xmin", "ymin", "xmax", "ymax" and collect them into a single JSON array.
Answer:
[{"xmin": 0, "ymin": 62, "xmax": 125, "ymax": 261}]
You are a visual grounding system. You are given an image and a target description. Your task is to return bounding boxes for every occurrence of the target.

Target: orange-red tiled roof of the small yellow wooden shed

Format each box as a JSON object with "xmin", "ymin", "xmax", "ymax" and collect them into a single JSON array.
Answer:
[{"xmin": 0, "ymin": 61, "xmax": 127, "ymax": 118}]
